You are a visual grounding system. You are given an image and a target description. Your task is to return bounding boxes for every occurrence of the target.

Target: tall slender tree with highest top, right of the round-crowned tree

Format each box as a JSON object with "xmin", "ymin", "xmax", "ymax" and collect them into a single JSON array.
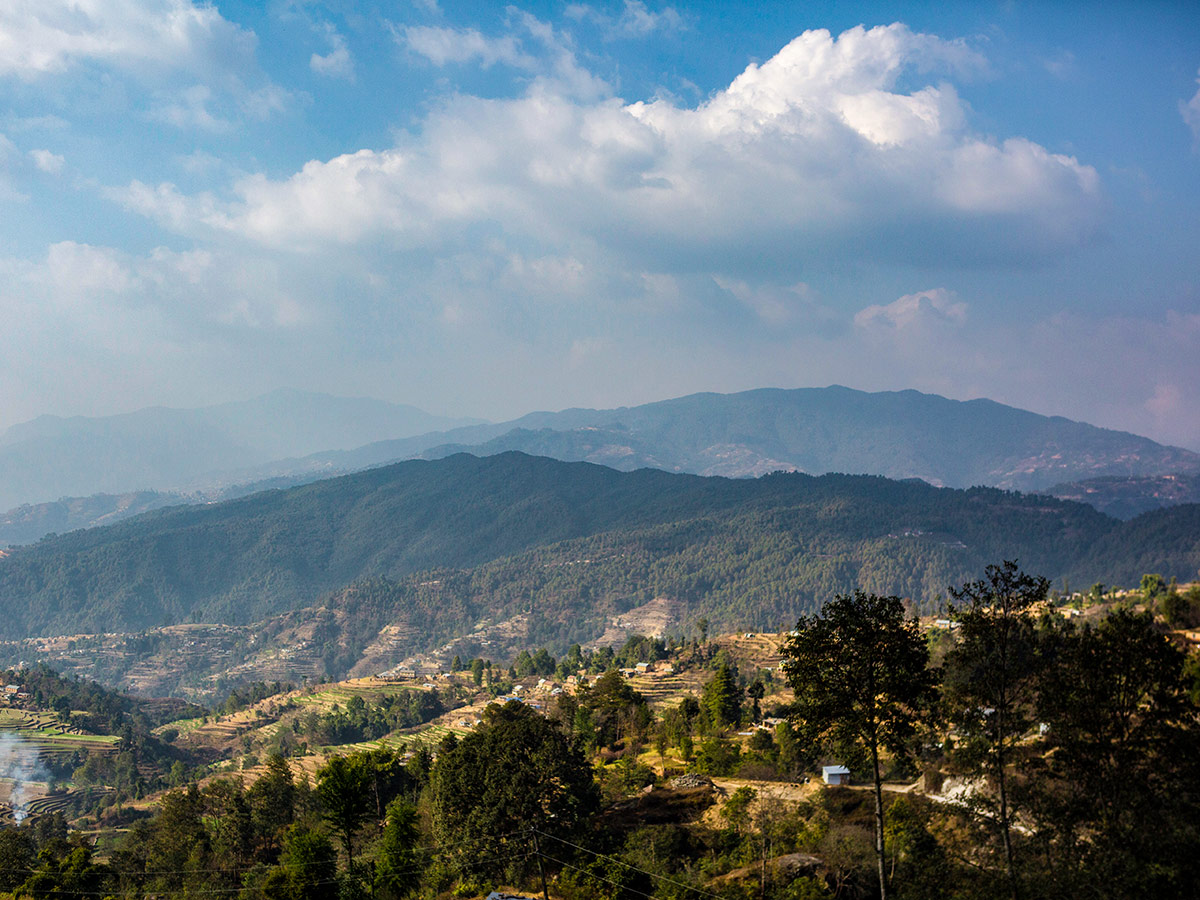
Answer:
[{"xmin": 946, "ymin": 560, "xmax": 1050, "ymax": 900}]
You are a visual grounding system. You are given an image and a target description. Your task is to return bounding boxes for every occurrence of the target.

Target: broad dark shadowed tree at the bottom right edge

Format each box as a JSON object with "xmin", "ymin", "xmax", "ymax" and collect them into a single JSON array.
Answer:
[{"xmin": 1038, "ymin": 608, "xmax": 1200, "ymax": 898}]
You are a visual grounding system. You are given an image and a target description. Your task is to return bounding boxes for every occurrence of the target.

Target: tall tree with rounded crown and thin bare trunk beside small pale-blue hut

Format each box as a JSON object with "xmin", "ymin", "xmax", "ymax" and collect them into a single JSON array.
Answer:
[{"xmin": 782, "ymin": 590, "xmax": 936, "ymax": 900}]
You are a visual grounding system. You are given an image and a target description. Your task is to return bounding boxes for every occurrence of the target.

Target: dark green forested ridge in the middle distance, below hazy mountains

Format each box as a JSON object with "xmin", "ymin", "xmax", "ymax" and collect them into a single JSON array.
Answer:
[{"xmin": 0, "ymin": 454, "xmax": 1200, "ymax": 640}]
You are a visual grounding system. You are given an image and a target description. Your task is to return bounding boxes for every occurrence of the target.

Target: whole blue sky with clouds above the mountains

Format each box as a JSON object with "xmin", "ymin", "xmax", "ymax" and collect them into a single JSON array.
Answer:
[{"xmin": 0, "ymin": 0, "xmax": 1200, "ymax": 450}]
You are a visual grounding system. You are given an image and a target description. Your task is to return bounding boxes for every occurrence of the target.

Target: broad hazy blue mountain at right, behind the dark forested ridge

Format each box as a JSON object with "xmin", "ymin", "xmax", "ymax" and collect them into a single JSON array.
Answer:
[{"xmin": 311, "ymin": 385, "xmax": 1200, "ymax": 491}]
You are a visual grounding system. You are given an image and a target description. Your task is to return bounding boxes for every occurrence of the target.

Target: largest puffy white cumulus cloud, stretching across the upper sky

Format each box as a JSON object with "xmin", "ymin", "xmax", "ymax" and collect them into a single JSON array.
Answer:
[{"xmin": 117, "ymin": 19, "xmax": 1102, "ymax": 271}]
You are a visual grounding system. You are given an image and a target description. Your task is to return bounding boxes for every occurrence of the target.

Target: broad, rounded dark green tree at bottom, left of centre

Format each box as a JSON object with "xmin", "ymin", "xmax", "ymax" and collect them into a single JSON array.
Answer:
[{"xmin": 431, "ymin": 702, "xmax": 599, "ymax": 872}]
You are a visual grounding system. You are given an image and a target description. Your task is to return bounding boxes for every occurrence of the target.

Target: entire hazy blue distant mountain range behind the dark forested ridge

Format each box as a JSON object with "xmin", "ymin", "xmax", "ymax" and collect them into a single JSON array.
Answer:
[{"xmin": 0, "ymin": 386, "xmax": 1200, "ymax": 546}]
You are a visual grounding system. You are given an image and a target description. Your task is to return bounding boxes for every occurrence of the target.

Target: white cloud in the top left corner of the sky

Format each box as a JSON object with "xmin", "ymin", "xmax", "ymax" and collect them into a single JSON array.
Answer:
[{"xmin": 0, "ymin": 0, "xmax": 254, "ymax": 79}]
